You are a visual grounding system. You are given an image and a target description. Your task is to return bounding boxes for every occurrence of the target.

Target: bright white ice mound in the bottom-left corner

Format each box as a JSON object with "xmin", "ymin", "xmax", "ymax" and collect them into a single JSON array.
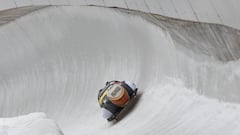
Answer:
[{"xmin": 0, "ymin": 113, "xmax": 63, "ymax": 135}]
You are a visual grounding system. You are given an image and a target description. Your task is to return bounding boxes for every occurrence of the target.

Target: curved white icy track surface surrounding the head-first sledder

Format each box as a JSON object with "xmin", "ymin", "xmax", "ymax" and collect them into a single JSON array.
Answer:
[{"xmin": 0, "ymin": 7, "xmax": 240, "ymax": 135}]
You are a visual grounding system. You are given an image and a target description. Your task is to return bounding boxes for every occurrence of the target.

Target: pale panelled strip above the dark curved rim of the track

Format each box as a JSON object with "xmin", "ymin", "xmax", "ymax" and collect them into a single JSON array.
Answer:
[{"xmin": 0, "ymin": 0, "xmax": 240, "ymax": 29}]
